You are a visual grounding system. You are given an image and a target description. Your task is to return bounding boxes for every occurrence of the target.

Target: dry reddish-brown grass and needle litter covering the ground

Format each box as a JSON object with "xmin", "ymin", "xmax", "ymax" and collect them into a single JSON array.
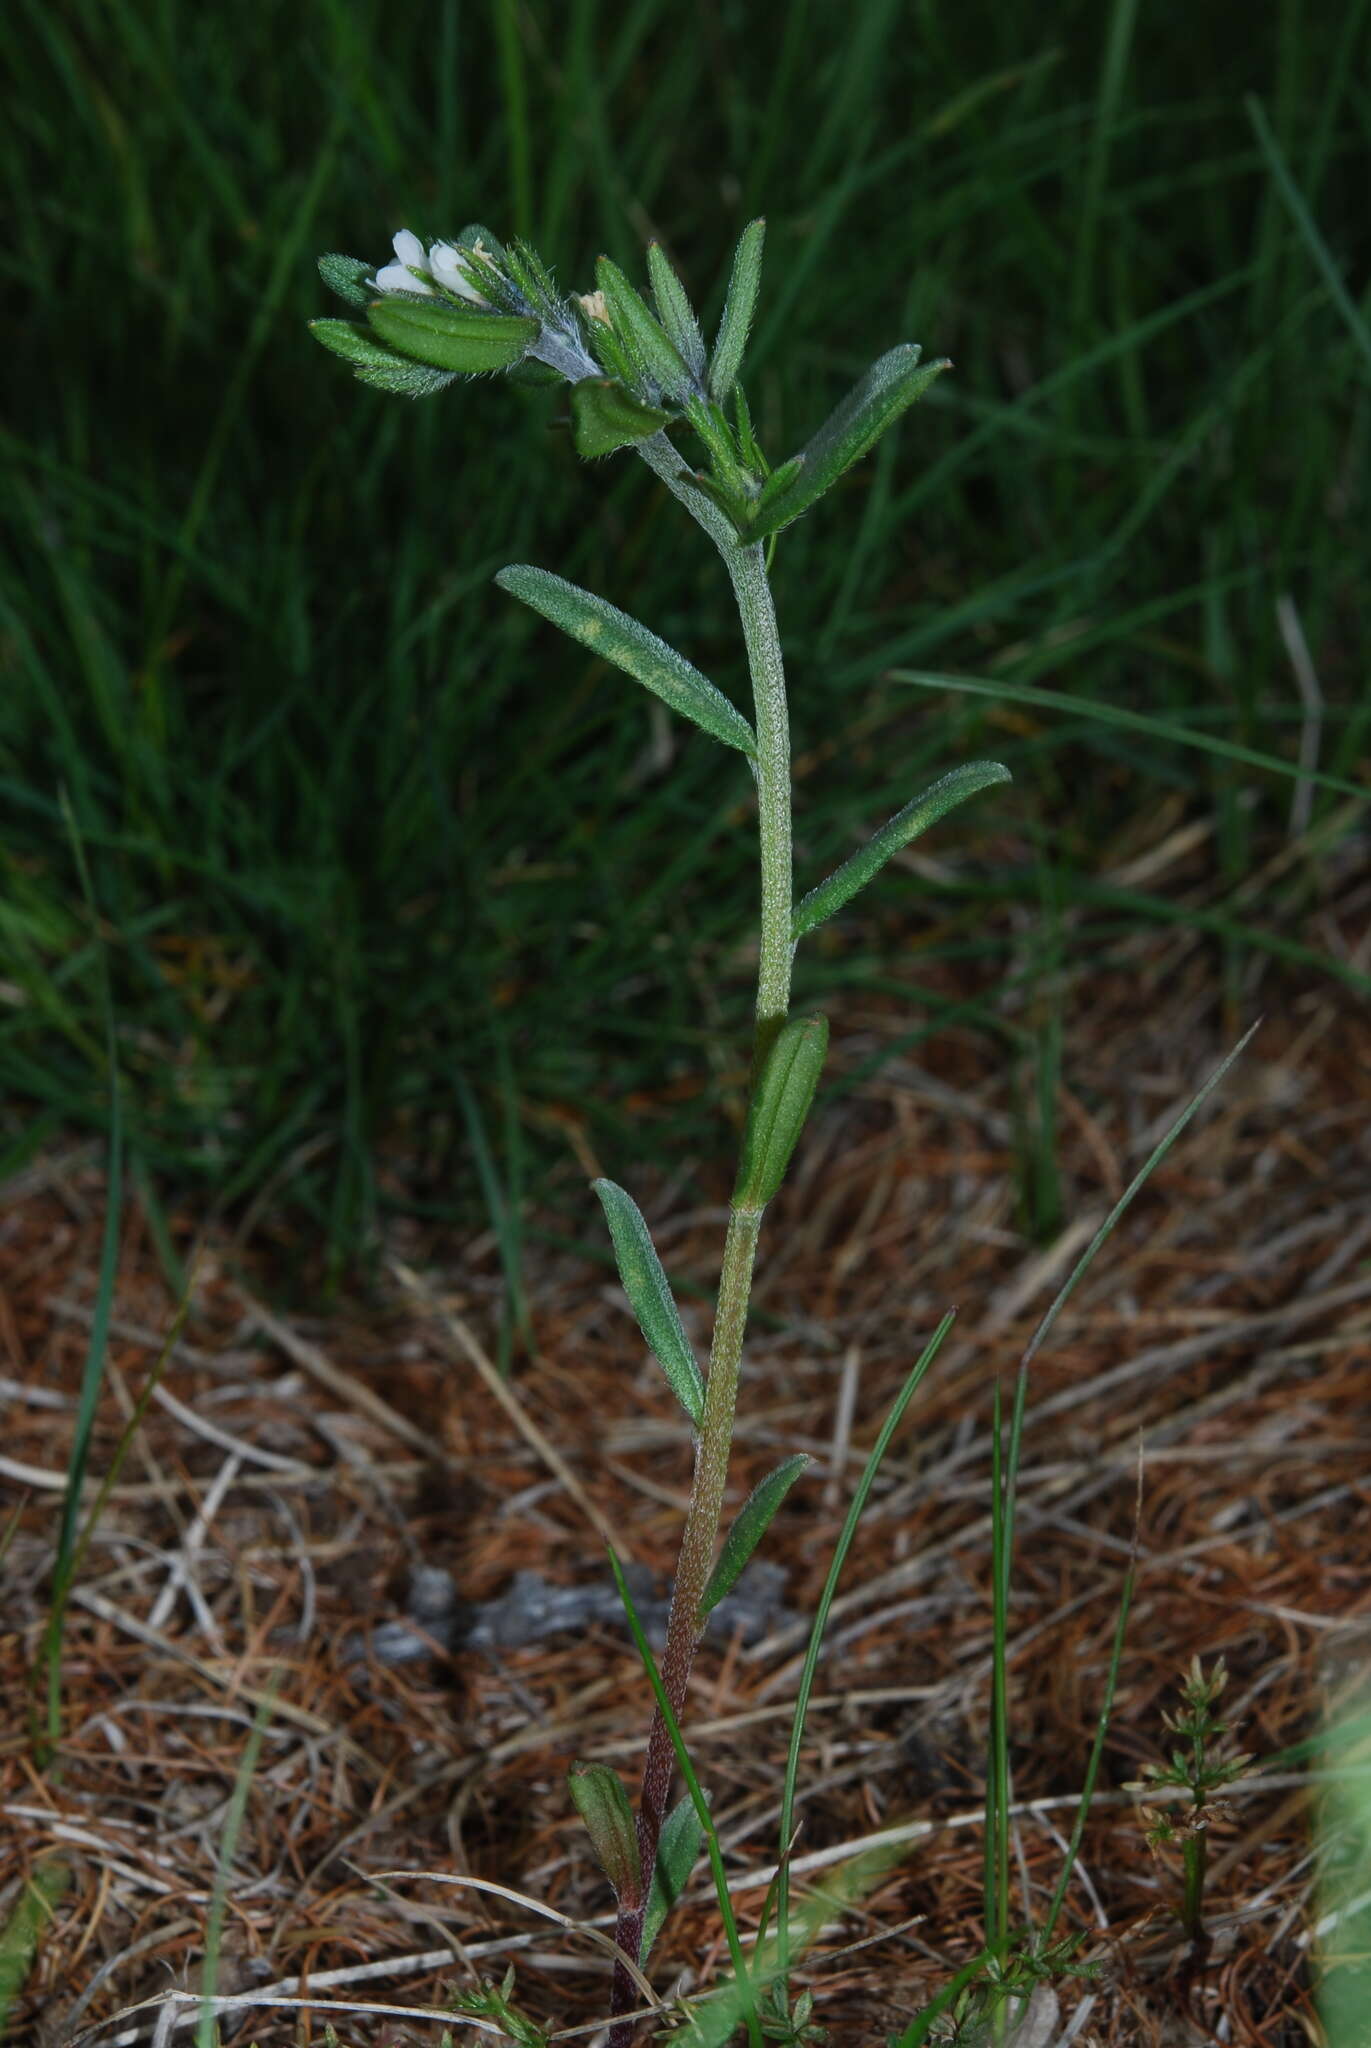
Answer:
[{"xmin": 0, "ymin": 847, "xmax": 1371, "ymax": 2048}]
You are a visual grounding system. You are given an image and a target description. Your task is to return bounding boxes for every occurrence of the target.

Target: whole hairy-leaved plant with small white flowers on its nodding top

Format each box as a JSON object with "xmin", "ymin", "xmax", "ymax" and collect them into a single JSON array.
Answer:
[{"xmin": 314, "ymin": 221, "xmax": 1008, "ymax": 2048}]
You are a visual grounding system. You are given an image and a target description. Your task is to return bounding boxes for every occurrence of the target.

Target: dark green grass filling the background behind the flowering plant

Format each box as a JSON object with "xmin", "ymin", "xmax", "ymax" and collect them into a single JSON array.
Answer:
[{"xmin": 0, "ymin": 0, "xmax": 1371, "ymax": 1294}]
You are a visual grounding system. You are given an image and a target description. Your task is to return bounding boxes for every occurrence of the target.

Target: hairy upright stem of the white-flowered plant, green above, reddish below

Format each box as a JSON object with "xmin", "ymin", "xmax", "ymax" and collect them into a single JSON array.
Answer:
[{"xmin": 611, "ymin": 434, "xmax": 793, "ymax": 2048}]
